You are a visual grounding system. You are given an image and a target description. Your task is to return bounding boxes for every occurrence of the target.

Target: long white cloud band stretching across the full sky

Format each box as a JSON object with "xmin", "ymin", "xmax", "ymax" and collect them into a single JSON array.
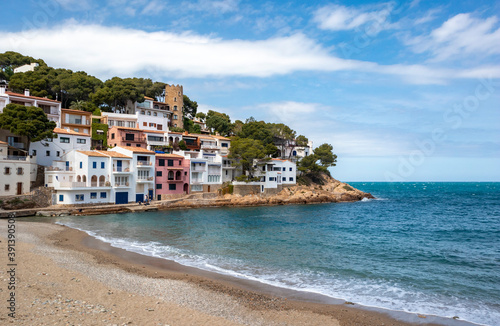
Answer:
[{"xmin": 0, "ymin": 20, "xmax": 500, "ymax": 84}]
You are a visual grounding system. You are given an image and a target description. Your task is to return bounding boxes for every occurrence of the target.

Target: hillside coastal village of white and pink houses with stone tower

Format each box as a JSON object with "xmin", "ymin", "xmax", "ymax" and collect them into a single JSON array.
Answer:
[{"xmin": 0, "ymin": 64, "xmax": 312, "ymax": 205}]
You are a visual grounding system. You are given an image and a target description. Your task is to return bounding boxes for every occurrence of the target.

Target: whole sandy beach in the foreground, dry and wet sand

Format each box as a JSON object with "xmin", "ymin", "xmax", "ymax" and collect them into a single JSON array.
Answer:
[{"xmin": 0, "ymin": 219, "xmax": 438, "ymax": 326}]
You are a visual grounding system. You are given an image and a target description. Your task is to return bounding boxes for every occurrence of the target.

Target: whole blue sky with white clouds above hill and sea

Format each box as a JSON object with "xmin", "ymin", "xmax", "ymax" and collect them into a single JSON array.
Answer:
[{"xmin": 0, "ymin": 0, "xmax": 500, "ymax": 181}]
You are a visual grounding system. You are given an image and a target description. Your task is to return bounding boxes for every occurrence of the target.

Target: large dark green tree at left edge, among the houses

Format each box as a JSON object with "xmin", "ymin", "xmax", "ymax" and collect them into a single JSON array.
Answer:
[{"xmin": 0, "ymin": 103, "xmax": 57, "ymax": 148}]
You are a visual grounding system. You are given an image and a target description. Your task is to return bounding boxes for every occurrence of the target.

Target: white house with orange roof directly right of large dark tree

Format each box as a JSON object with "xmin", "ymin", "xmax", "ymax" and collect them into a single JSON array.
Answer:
[{"xmin": 29, "ymin": 128, "xmax": 91, "ymax": 166}]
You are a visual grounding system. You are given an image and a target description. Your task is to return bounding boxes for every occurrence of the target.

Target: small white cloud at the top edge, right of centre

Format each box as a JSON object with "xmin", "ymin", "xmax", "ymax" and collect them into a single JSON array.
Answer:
[{"xmin": 313, "ymin": 5, "xmax": 392, "ymax": 31}]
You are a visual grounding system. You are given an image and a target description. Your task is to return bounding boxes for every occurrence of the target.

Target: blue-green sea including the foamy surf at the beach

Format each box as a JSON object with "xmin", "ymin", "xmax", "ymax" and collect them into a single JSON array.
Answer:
[{"xmin": 51, "ymin": 182, "xmax": 500, "ymax": 325}]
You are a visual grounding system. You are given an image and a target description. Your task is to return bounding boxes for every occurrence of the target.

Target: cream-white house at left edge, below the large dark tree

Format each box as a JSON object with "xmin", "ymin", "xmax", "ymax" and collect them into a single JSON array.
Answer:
[{"xmin": 0, "ymin": 141, "xmax": 37, "ymax": 196}]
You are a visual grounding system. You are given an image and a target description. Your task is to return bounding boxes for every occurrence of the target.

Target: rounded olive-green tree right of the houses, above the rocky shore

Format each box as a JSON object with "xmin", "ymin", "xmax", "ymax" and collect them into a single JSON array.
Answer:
[{"xmin": 228, "ymin": 137, "xmax": 266, "ymax": 175}]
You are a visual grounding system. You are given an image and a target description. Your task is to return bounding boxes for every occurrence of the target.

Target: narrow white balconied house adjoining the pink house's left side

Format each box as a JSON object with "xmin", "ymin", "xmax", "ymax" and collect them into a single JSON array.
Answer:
[{"xmin": 109, "ymin": 146, "xmax": 156, "ymax": 202}]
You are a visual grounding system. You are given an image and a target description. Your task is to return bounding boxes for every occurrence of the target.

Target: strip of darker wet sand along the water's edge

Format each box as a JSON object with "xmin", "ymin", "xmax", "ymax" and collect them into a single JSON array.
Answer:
[{"xmin": 4, "ymin": 221, "xmax": 471, "ymax": 325}]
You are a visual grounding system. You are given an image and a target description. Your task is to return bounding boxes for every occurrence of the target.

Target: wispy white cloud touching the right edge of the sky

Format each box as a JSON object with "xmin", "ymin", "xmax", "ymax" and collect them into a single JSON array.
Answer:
[{"xmin": 406, "ymin": 13, "xmax": 500, "ymax": 62}]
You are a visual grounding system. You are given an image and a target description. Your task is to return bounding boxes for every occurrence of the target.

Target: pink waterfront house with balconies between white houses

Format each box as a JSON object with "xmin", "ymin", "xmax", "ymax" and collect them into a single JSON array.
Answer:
[{"xmin": 155, "ymin": 154, "xmax": 191, "ymax": 200}]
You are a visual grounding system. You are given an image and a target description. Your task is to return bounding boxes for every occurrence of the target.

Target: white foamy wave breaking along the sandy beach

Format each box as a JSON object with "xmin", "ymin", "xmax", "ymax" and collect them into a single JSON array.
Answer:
[{"xmin": 56, "ymin": 222, "xmax": 500, "ymax": 325}]
